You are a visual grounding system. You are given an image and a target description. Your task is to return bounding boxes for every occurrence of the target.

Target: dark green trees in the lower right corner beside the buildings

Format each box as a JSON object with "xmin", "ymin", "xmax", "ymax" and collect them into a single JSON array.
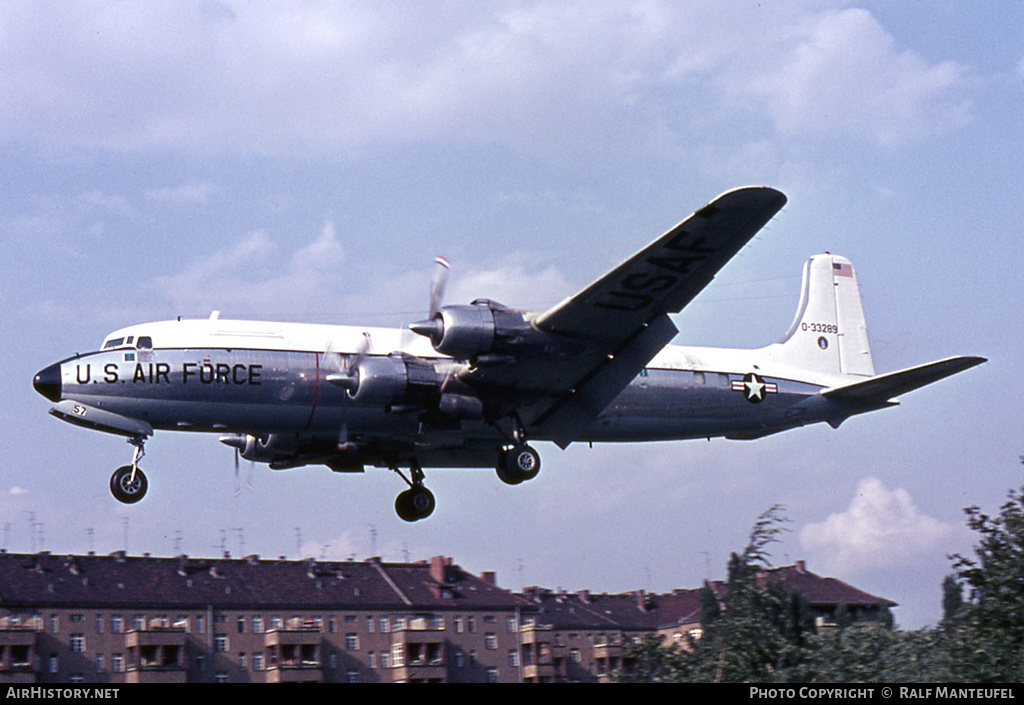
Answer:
[{"xmin": 624, "ymin": 467, "xmax": 1024, "ymax": 682}]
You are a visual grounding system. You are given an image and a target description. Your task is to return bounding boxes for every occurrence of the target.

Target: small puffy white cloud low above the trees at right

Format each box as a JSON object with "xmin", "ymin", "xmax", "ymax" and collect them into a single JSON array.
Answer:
[{"xmin": 800, "ymin": 478, "xmax": 955, "ymax": 574}]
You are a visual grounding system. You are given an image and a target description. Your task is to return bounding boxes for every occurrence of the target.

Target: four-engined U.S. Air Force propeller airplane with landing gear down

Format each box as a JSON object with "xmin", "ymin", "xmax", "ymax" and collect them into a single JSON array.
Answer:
[{"xmin": 34, "ymin": 186, "xmax": 986, "ymax": 522}]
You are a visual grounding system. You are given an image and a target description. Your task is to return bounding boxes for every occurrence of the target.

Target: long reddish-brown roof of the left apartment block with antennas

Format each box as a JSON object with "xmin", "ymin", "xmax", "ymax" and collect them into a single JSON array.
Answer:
[{"xmin": 0, "ymin": 552, "xmax": 528, "ymax": 611}]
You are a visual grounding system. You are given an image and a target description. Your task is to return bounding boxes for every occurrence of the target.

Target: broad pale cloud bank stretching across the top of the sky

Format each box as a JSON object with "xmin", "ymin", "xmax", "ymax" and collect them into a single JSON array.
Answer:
[{"xmin": 0, "ymin": 0, "xmax": 970, "ymax": 155}]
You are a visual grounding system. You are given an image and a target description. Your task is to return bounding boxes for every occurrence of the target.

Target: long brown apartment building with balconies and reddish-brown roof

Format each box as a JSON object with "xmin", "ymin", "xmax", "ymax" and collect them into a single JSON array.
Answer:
[{"xmin": 0, "ymin": 552, "xmax": 893, "ymax": 683}]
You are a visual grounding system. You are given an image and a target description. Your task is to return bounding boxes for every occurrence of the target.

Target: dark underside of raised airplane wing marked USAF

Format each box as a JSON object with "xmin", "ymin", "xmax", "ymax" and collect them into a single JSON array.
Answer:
[{"xmin": 461, "ymin": 186, "xmax": 785, "ymax": 448}]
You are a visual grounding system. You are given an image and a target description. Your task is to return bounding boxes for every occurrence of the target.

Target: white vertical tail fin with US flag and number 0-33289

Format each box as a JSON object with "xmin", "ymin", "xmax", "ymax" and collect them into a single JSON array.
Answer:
[{"xmin": 764, "ymin": 253, "xmax": 874, "ymax": 377}]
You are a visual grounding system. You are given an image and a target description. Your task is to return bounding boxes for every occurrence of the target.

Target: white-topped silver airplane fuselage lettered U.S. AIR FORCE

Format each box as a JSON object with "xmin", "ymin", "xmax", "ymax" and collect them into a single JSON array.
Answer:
[{"xmin": 34, "ymin": 319, "xmax": 856, "ymax": 467}]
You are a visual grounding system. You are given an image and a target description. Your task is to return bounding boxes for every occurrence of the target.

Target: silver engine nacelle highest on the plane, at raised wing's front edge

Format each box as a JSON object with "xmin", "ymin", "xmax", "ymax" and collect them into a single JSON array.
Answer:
[{"xmin": 410, "ymin": 299, "xmax": 548, "ymax": 360}]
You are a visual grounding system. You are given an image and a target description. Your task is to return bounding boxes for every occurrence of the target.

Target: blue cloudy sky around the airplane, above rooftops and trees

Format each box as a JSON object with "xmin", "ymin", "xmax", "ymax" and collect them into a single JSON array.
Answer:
[{"xmin": 0, "ymin": 0, "xmax": 1024, "ymax": 628}]
